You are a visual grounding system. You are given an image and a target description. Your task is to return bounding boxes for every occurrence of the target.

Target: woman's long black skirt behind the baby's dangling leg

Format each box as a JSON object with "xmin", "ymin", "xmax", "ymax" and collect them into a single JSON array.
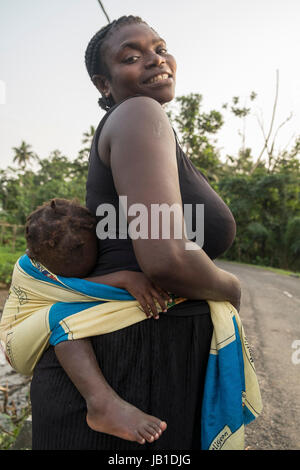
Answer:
[{"xmin": 31, "ymin": 301, "xmax": 213, "ymax": 450}]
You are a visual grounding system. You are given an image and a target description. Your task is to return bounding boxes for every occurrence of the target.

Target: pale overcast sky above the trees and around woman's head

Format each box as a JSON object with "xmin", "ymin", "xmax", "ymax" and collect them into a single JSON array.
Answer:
[{"xmin": 0, "ymin": 0, "xmax": 300, "ymax": 169}]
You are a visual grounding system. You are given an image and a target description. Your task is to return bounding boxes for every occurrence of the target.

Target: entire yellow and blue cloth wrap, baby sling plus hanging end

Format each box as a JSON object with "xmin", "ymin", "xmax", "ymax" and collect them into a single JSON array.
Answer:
[{"xmin": 0, "ymin": 255, "xmax": 262, "ymax": 450}]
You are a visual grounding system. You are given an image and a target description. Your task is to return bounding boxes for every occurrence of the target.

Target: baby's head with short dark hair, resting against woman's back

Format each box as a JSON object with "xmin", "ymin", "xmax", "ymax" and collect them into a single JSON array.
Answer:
[{"xmin": 25, "ymin": 199, "xmax": 98, "ymax": 277}]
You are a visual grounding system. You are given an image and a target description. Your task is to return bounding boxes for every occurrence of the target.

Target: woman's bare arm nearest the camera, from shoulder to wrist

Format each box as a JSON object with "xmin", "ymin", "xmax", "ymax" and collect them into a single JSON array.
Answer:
[{"xmin": 103, "ymin": 97, "xmax": 240, "ymax": 306}]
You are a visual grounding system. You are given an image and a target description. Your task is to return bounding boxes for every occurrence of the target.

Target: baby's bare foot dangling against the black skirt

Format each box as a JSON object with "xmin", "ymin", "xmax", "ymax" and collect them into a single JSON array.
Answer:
[{"xmin": 86, "ymin": 394, "xmax": 167, "ymax": 444}]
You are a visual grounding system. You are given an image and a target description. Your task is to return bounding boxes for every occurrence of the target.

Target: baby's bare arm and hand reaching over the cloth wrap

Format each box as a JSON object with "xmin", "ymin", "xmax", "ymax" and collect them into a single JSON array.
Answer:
[{"xmin": 85, "ymin": 270, "xmax": 170, "ymax": 319}]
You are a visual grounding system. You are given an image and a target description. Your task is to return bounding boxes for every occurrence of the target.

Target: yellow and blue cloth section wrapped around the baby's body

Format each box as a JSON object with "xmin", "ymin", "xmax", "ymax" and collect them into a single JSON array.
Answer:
[{"xmin": 0, "ymin": 255, "xmax": 186, "ymax": 375}]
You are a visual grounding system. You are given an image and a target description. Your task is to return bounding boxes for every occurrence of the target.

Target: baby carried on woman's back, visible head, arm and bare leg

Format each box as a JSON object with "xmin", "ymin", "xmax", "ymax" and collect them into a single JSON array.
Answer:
[{"xmin": 25, "ymin": 199, "xmax": 170, "ymax": 444}]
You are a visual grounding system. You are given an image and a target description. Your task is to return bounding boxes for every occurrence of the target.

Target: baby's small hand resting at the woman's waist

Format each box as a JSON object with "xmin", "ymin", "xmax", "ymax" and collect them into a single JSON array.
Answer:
[{"xmin": 124, "ymin": 271, "xmax": 170, "ymax": 320}]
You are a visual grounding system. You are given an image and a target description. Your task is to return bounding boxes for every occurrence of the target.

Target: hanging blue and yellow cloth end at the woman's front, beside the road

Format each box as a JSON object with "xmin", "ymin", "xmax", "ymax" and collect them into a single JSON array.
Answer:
[{"xmin": 201, "ymin": 300, "xmax": 262, "ymax": 450}]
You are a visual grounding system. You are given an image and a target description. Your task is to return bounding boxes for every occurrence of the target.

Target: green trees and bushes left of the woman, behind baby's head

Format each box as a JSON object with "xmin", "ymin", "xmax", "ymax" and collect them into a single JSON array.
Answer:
[{"xmin": 0, "ymin": 127, "xmax": 95, "ymax": 285}]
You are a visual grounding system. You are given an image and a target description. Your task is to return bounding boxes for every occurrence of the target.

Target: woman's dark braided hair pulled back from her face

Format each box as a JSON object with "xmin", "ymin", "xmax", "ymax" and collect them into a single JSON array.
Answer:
[{"xmin": 85, "ymin": 15, "xmax": 147, "ymax": 111}]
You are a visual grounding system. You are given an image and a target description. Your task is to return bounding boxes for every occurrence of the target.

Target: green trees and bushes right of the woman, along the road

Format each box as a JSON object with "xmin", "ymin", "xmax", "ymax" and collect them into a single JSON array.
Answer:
[{"xmin": 168, "ymin": 92, "xmax": 300, "ymax": 271}]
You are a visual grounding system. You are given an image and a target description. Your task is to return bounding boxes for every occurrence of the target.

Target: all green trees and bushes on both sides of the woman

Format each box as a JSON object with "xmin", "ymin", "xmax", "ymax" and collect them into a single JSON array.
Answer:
[{"xmin": 0, "ymin": 92, "xmax": 300, "ymax": 284}]
